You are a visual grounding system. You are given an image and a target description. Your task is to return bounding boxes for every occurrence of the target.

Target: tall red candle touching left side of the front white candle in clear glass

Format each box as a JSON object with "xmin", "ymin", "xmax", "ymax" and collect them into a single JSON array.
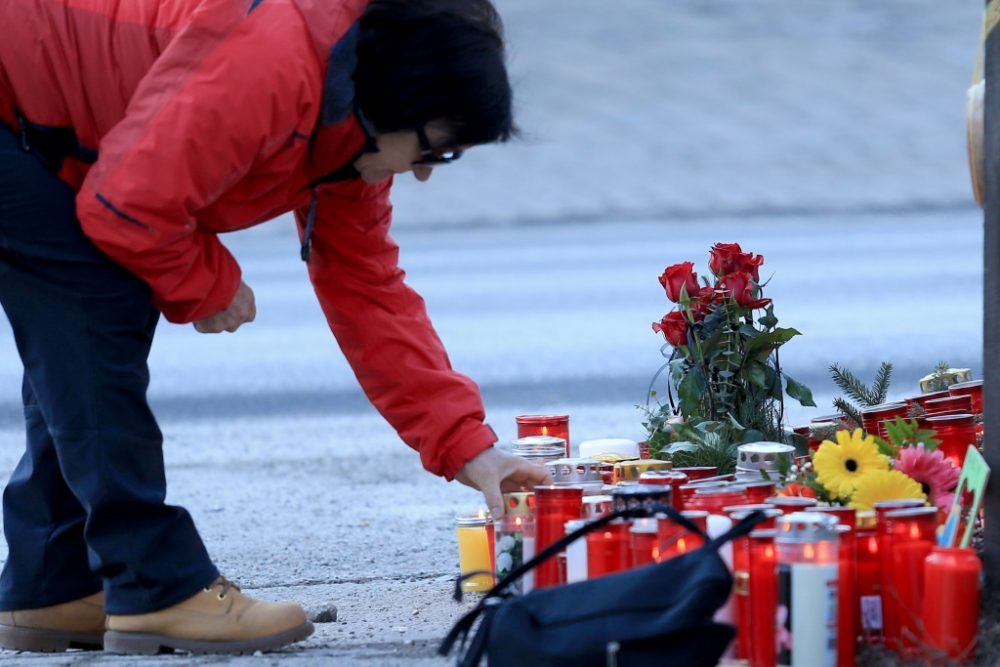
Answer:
[{"xmin": 747, "ymin": 530, "xmax": 778, "ymax": 667}]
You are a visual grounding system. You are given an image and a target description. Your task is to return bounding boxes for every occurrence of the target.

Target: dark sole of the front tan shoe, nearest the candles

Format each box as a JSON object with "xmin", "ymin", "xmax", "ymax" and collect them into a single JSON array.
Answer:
[{"xmin": 104, "ymin": 621, "xmax": 313, "ymax": 655}]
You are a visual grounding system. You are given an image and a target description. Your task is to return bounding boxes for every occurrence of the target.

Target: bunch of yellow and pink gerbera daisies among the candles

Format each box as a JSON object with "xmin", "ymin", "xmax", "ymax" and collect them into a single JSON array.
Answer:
[{"xmin": 786, "ymin": 418, "xmax": 961, "ymax": 510}]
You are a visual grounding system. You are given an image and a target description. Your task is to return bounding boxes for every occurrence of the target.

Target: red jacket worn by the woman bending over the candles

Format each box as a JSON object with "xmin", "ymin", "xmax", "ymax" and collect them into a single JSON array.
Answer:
[{"xmin": 0, "ymin": 0, "xmax": 496, "ymax": 478}]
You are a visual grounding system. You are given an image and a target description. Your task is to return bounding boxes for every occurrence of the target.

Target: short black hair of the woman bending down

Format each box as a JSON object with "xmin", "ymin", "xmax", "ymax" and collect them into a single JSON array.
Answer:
[{"xmin": 354, "ymin": 0, "xmax": 517, "ymax": 145}]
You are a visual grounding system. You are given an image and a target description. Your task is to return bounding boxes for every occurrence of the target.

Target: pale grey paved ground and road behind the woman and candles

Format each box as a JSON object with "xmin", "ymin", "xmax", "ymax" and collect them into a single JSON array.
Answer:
[{"xmin": 0, "ymin": 0, "xmax": 982, "ymax": 667}]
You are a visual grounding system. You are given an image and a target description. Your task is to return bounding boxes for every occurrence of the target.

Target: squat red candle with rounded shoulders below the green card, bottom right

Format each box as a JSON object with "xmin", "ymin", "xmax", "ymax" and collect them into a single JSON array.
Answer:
[{"xmin": 921, "ymin": 547, "xmax": 983, "ymax": 664}]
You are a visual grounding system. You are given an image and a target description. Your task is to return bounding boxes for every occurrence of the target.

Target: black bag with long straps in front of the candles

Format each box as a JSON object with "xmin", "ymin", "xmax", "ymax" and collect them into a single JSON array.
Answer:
[{"xmin": 438, "ymin": 507, "xmax": 764, "ymax": 667}]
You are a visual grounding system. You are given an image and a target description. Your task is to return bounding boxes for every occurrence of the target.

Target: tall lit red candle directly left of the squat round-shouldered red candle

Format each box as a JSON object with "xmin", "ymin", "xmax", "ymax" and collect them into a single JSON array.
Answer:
[{"xmin": 882, "ymin": 507, "xmax": 938, "ymax": 658}]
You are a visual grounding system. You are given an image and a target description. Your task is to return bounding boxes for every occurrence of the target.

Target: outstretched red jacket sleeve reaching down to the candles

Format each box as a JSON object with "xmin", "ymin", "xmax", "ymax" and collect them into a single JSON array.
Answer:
[{"xmin": 296, "ymin": 179, "xmax": 496, "ymax": 480}]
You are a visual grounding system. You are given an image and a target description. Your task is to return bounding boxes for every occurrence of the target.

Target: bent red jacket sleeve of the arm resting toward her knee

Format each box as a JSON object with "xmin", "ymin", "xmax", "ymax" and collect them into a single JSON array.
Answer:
[{"xmin": 77, "ymin": 2, "xmax": 322, "ymax": 322}]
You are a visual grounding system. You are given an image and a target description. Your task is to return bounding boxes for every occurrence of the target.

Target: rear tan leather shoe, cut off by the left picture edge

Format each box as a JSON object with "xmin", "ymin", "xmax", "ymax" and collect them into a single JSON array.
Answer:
[{"xmin": 0, "ymin": 593, "xmax": 104, "ymax": 653}]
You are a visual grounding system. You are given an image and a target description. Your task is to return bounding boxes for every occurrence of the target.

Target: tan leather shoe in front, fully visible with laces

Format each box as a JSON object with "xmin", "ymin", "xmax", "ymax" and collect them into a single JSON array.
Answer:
[{"xmin": 104, "ymin": 577, "xmax": 313, "ymax": 655}]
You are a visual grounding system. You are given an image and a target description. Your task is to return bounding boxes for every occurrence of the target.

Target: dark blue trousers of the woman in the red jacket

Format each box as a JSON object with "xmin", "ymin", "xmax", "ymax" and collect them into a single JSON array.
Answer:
[{"xmin": 0, "ymin": 125, "xmax": 218, "ymax": 614}]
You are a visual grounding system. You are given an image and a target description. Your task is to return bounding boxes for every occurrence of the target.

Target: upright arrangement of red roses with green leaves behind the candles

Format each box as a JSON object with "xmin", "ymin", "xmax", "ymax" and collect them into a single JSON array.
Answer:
[{"xmin": 643, "ymin": 243, "xmax": 815, "ymax": 472}]
